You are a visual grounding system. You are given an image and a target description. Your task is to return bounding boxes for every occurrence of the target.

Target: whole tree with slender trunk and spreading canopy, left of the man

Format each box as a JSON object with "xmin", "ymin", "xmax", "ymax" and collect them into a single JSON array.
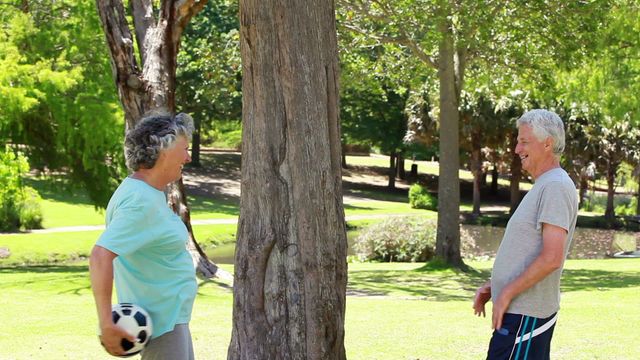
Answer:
[{"xmin": 340, "ymin": 0, "xmax": 602, "ymax": 266}]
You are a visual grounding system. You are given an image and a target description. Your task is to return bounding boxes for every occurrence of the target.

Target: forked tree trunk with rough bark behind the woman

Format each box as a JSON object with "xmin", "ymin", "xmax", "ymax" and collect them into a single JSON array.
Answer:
[{"xmin": 96, "ymin": 0, "xmax": 226, "ymax": 277}]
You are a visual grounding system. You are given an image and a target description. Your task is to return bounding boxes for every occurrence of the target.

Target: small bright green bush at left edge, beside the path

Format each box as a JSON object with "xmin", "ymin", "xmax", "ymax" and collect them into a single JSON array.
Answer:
[{"xmin": 0, "ymin": 147, "xmax": 42, "ymax": 231}]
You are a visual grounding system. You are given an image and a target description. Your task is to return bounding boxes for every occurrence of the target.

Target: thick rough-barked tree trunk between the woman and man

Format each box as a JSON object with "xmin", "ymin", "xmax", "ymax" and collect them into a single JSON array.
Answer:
[{"xmin": 228, "ymin": 0, "xmax": 347, "ymax": 360}]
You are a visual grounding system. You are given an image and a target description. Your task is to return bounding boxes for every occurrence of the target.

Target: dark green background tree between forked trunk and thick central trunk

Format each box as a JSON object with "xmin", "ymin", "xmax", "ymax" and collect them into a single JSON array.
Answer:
[{"xmin": 176, "ymin": 0, "xmax": 242, "ymax": 166}]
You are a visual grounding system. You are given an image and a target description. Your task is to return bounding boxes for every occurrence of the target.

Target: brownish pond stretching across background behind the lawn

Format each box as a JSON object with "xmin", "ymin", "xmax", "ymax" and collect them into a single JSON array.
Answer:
[{"xmin": 207, "ymin": 225, "xmax": 640, "ymax": 264}]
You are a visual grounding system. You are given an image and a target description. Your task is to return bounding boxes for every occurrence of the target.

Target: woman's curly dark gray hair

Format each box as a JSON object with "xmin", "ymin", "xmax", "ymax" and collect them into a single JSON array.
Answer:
[{"xmin": 124, "ymin": 113, "xmax": 194, "ymax": 171}]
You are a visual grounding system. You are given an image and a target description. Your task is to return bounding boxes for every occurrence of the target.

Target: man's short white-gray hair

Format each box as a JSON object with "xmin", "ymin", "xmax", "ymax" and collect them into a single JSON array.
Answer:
[{"xmin": 518, "ymin": 109, "xmax": 565, "ymax": 156}]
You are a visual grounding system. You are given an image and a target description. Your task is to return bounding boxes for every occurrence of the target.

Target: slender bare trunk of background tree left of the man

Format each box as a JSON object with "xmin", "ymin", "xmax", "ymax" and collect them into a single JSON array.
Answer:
[{"xmin": 436, "ymin": 14, "xmax": 464, "ymax": 266}]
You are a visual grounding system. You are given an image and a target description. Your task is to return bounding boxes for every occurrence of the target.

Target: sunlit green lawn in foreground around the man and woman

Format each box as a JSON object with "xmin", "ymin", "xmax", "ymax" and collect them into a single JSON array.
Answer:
[{"xmin": 0, "ymin": 259, "xmax": 640, "ymax": 360}]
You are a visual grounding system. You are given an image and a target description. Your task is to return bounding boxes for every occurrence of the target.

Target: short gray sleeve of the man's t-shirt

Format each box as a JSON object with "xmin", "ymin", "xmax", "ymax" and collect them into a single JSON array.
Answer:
[{"xmin": 536, "ymin": 182, "xmax": 575, "ymax": 231}]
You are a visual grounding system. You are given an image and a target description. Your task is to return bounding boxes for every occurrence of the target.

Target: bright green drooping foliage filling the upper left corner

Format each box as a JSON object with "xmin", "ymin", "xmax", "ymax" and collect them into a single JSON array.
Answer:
[{"xmin": 0, "ymin": 0, "xmax": 125, "ymax": 206}]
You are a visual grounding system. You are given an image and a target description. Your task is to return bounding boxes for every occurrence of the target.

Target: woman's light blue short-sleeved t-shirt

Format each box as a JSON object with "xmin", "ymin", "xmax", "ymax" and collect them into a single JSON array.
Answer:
[{"xmin": 96, "ymin": 178, "xmax": 197, "ymax": 337}]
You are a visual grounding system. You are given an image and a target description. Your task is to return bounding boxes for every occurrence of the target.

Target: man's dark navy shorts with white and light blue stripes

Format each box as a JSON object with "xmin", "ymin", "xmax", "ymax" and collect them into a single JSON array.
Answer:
[{"xmin": 487, "ymin": 313, "xmax": 558, "ymax": 360}]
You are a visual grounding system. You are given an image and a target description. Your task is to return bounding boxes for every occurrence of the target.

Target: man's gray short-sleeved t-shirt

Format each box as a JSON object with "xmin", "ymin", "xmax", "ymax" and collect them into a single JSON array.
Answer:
[{"xmin": 491, "ymin": 168, "xmax": 578, "ymax": 318}]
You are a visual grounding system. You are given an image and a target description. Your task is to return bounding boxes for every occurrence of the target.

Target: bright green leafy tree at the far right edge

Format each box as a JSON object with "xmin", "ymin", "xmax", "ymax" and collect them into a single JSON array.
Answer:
[{"xmin": 558, "ymin": 0, "xmax": 640, "ymax": 221}]
